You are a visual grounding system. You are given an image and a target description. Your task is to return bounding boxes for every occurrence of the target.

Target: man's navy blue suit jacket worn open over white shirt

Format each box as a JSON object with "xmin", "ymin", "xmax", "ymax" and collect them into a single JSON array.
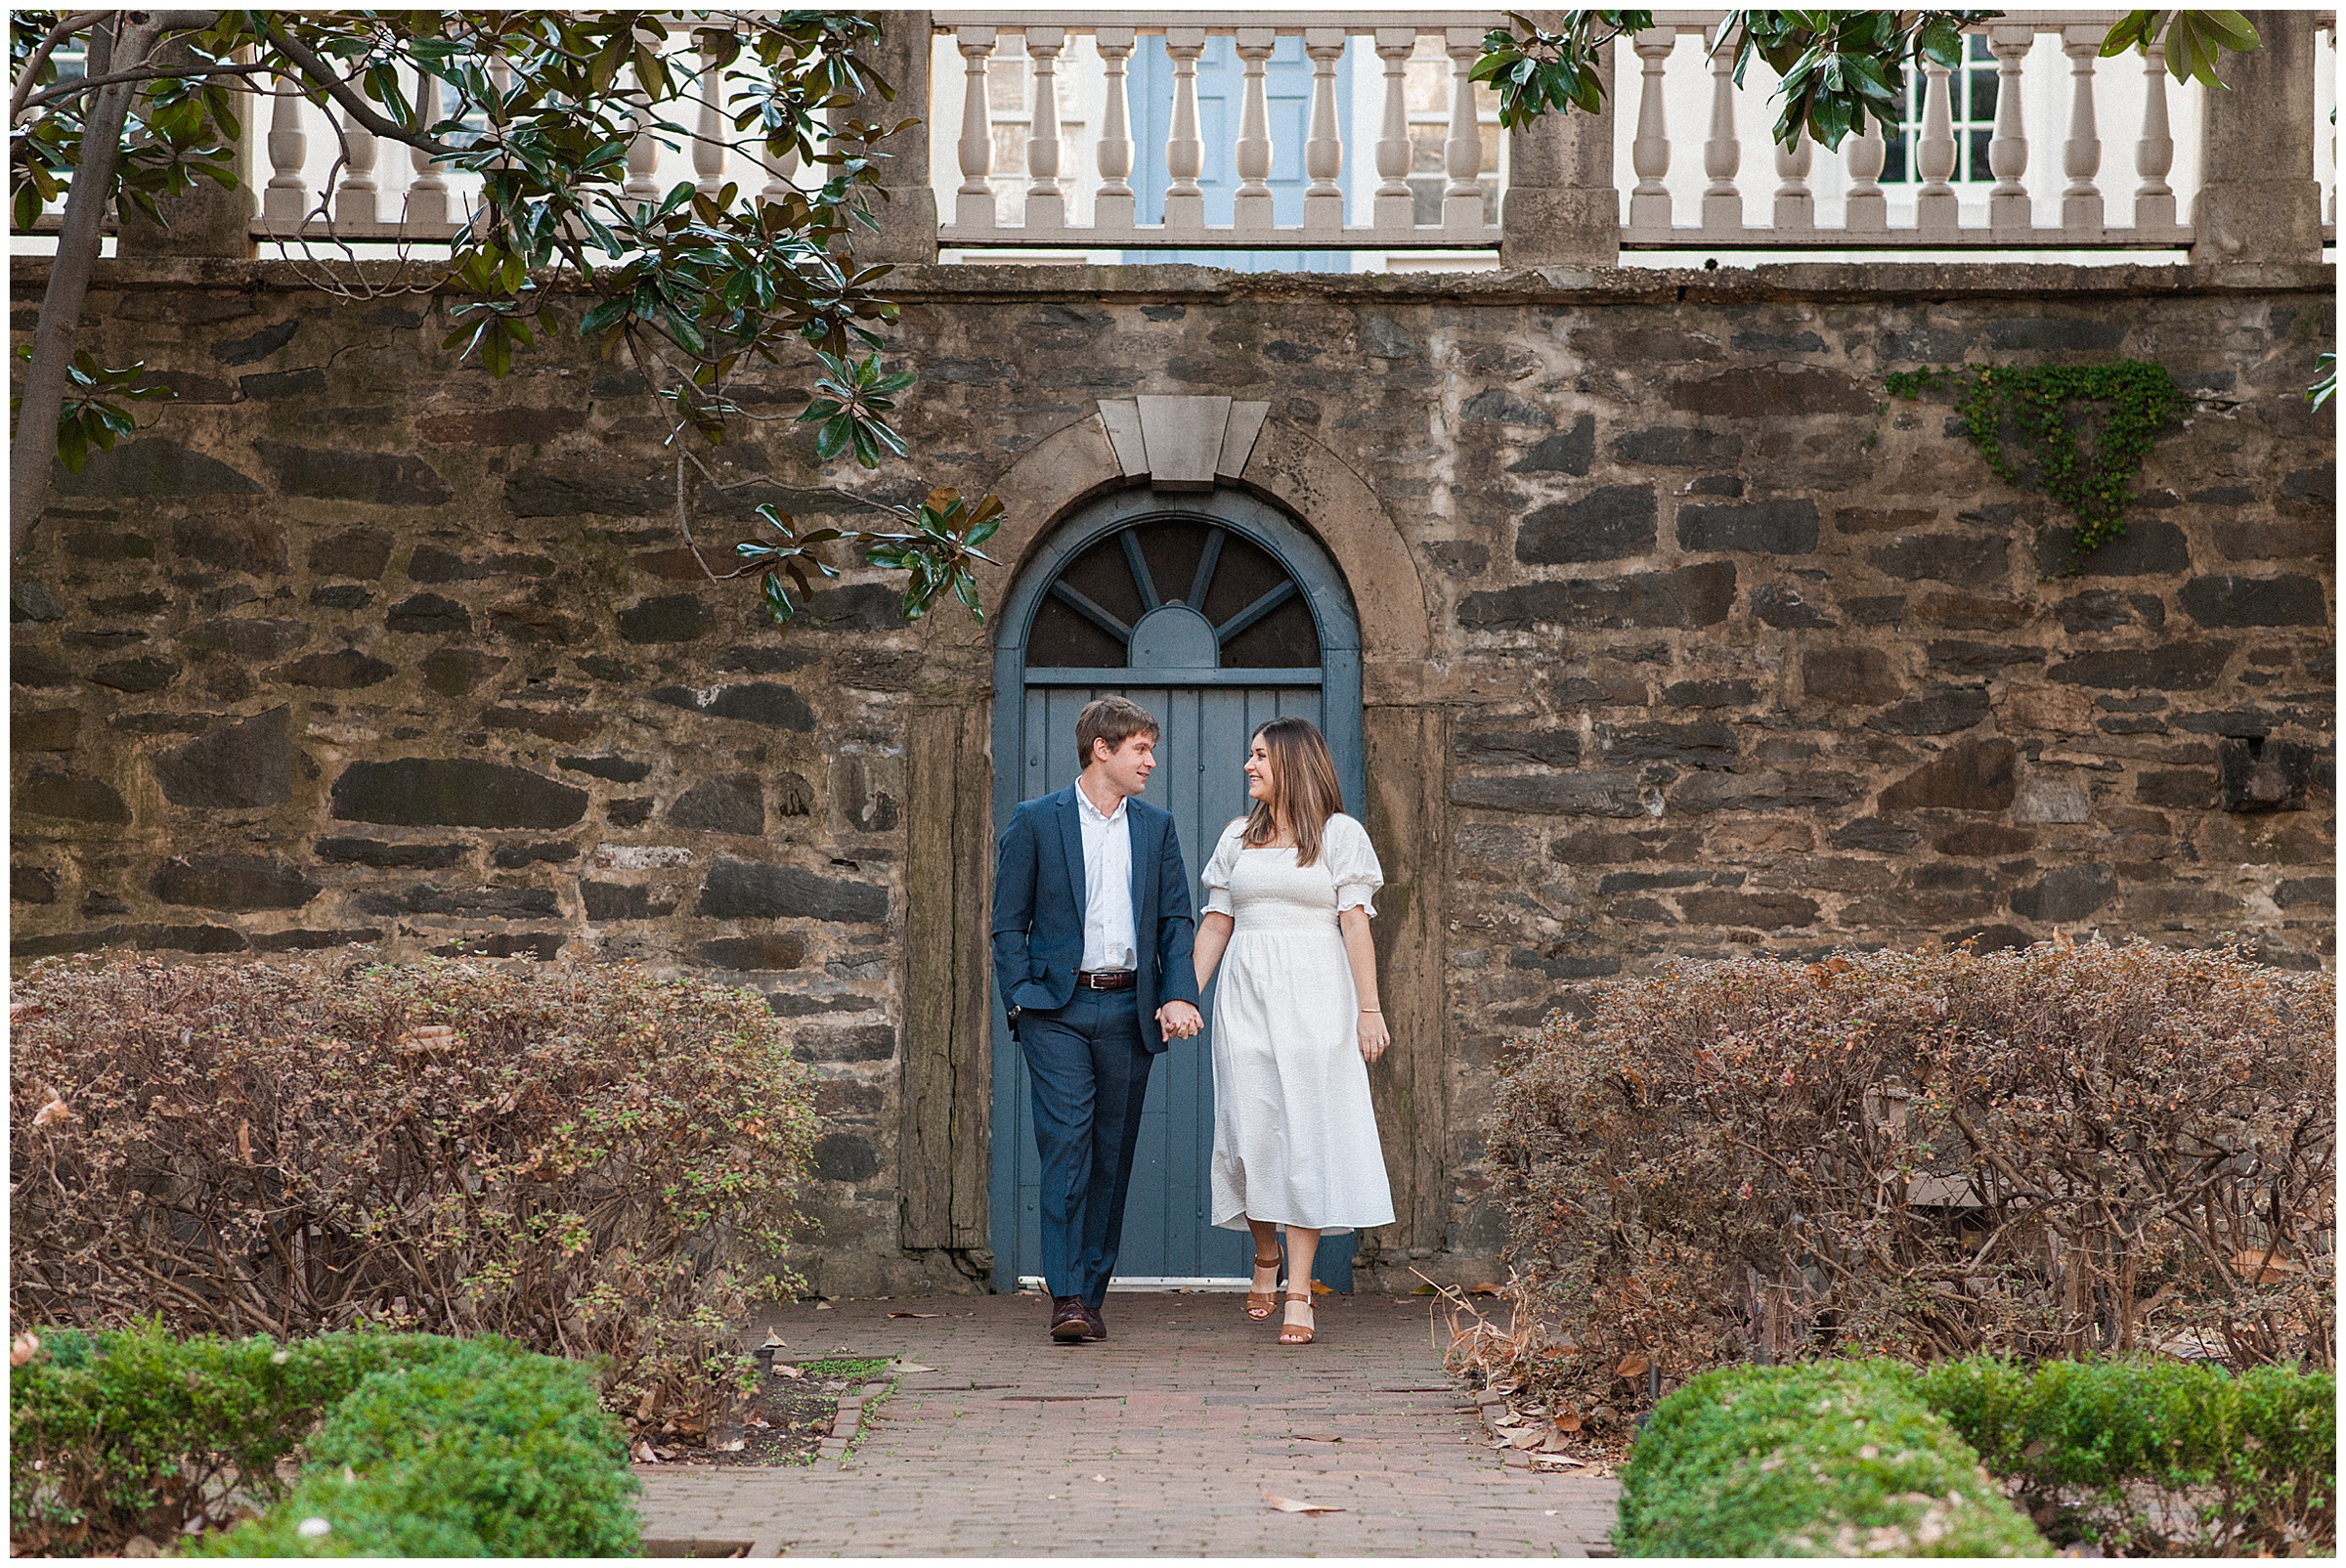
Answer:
[{"xmin": 995, "ymin": 784, "xmax": 1196, "ymax": 1052}]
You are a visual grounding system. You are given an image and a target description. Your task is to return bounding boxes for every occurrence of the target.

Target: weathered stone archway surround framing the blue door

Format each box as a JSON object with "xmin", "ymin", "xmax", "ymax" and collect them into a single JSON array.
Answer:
[{"xmin": 898, "ymin": 399, "xmax": 1453, "ymax": 1284}]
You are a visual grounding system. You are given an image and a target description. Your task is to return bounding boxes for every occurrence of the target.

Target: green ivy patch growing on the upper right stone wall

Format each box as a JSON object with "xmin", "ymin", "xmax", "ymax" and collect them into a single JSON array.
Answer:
[{"xmin": 1884, "ymin": 359, "xmax": 2184, "ymax": 558}]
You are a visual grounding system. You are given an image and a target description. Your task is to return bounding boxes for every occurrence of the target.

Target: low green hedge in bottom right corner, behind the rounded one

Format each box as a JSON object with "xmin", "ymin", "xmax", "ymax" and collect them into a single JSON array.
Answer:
[{"xmin": 1917, "ymin": 1357, "xmax": 2336, "ymax": 1556}]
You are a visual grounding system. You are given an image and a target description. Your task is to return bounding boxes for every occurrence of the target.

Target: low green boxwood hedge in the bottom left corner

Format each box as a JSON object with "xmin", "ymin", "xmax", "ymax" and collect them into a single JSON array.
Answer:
[{"xmin": 10, "ymin": 1322, "xmax": 635, "ymax": 1556}]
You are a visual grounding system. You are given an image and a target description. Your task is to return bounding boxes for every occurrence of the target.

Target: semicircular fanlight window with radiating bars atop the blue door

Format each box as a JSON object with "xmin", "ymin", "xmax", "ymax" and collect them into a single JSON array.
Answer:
[{"xmin": 1025, "ymin": 519, "xmax": 1321, "ymax": 672}]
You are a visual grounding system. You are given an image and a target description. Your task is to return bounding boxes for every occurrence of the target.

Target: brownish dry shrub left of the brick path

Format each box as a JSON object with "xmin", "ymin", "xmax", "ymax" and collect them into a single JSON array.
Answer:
[{"xmin": 10, "ymin": 958, "xmax": 814, "ymax": 1437}]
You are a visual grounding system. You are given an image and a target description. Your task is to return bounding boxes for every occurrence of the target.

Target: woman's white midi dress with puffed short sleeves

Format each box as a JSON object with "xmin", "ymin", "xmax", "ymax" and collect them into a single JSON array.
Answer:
[{"xmin": 1201, "ymin": 814, "xmax": 1394, "ymax": 1233}]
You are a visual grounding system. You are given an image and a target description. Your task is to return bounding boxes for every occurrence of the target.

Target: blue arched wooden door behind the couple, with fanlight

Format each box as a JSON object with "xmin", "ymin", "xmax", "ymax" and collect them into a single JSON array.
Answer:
[{"xmin": 990, "ymin": 491, "xmax": 1366, "ymax": 1291}]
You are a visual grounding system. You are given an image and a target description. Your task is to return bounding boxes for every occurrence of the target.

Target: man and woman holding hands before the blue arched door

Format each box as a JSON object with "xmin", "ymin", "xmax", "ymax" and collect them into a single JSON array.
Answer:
[{"xmin": 992, "ymin": 697, "xmax": 1394, "ymax": 1345}]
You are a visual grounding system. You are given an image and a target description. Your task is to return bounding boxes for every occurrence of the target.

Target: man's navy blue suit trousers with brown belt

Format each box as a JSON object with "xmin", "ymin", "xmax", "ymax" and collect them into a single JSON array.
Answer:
[{"xmin": 1019, "ymin": 988, "xmax": 1156, "ymax": 1307}]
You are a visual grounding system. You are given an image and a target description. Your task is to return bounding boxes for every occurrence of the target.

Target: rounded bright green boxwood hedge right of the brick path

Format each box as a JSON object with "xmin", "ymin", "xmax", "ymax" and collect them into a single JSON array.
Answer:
[{"xmin": 1614, "ymin": 1362, "xmax": 2051, "ymax": 1556}]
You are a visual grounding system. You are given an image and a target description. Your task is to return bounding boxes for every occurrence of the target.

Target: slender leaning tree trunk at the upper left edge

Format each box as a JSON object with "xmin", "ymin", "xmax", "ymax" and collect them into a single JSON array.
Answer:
[{"xmin": 10, "ymin": 12, "xmax": 162, "ymax": 558}]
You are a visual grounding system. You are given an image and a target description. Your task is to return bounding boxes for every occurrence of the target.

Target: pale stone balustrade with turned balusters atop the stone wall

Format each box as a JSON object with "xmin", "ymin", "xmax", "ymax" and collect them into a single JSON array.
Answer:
[{"xmin": 9, "ymin": 12, "xmax": 2336, "ymax": 256}]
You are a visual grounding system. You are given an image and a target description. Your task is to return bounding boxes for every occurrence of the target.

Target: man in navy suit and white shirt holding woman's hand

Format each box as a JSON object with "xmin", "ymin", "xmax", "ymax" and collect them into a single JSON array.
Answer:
[{"xmin": 995, "ymin": 697, "xmax": 1203, "ymax": 1345}]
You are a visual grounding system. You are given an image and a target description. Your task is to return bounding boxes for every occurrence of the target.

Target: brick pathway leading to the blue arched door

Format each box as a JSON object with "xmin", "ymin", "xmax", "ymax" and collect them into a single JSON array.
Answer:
[{"xmin": 638, "ymin": 1293, "xmax": 1617, "ymax": 1556}]
